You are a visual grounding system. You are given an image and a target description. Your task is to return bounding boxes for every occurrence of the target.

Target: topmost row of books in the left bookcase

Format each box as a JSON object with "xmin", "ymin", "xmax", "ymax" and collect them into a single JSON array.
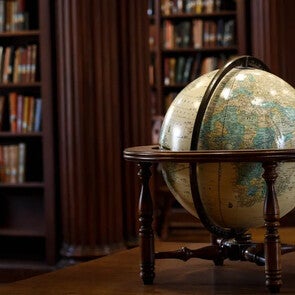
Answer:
[{"xmin": 0, "ymin": 0, "xmax": 29, "ymax": 32}]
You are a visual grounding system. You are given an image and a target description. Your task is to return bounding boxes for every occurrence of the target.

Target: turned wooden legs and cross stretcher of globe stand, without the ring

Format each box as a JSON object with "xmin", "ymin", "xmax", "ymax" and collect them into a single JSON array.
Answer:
[{"xmin": 138, "ymin": 162, "xmax": 295, "ymax": 293}]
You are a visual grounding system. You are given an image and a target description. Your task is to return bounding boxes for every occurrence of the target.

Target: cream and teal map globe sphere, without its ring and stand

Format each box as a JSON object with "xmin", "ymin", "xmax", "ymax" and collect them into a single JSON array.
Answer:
[{"xmin": 159, "ymin": 68, "xmax": 295, "ymax": 229}]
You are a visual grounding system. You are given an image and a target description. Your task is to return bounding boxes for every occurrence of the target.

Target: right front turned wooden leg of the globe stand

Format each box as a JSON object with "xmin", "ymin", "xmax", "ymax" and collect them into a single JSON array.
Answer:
[{"xmin": 263, "ymin": 162, "xmax": 282, "ymax": 293}]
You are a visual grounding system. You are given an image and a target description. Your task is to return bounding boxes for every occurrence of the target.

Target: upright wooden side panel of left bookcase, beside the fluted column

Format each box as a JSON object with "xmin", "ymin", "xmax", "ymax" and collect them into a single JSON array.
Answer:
[{"xmin": 38, "ymin": 1, "xmax": 58, "ymax": 265}]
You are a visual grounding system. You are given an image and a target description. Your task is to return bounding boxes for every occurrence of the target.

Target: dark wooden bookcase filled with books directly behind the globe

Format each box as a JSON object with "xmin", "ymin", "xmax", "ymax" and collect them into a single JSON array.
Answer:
[{"xmin": 147, "ymin": 0, "xmax": 249, "ymax": 240}]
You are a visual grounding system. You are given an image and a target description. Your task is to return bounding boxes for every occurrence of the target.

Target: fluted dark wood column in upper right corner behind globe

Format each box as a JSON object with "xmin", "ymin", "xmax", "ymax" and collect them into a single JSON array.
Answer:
[{"xmin": 251, "ymin": 0, "xmax": 295, "ymax": 86}]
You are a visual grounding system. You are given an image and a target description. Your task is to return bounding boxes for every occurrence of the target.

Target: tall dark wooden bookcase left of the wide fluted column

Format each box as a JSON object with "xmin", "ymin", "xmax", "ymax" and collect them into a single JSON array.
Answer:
[{"xmin": 0, "ymin": 0, "xmax": 57, "ymax": 268}]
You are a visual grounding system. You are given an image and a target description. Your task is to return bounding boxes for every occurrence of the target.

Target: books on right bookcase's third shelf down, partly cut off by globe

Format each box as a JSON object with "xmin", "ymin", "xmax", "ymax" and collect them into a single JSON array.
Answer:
[{"xmin": 164, "ymin": 55, "xmax": 227, "ymax": 86}]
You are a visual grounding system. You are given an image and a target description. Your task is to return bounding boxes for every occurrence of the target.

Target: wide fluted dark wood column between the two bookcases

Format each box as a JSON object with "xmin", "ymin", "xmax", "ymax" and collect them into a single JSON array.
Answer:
[{"xmin": 56, "ymin": 0, "xmax": 150, "ymax": 258}]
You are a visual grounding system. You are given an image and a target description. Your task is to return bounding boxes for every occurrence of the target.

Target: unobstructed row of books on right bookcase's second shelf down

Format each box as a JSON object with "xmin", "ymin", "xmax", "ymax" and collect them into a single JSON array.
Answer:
[{"xmin": 163, "ymin": 19, "xmax": 236, "ymax": 49}]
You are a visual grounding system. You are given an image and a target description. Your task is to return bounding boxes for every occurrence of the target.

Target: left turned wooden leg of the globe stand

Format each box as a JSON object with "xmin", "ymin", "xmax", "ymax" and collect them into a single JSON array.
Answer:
[{"xmin": 138, "ymin": 163, "xmax": 155, "ymax": 285}]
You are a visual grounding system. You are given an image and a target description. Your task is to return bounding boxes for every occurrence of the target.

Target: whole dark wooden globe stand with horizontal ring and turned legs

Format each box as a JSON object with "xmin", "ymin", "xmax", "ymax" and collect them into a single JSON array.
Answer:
[{"xmin": 124, "ymin": 146, "xmax": 295, "ymax": 293}]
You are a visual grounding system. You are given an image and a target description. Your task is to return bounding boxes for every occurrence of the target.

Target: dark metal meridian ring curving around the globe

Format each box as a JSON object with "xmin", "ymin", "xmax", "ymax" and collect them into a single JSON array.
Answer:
[{"xmin": 190, "ymin": 55, "xmax": 270, "ymax": 238}]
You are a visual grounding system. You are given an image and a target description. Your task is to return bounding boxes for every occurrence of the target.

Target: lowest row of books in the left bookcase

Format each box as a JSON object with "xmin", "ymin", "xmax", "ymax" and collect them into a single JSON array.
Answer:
[{"xmin": 0, "ymin": 143, "xmax": 26, "ymax": 183}]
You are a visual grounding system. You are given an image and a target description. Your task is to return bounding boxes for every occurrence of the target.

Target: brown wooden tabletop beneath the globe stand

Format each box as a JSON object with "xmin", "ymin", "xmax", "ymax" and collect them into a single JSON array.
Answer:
[{"xmin": 0, "ymin": 242, "xmax": 295, "ymax": 295}]
